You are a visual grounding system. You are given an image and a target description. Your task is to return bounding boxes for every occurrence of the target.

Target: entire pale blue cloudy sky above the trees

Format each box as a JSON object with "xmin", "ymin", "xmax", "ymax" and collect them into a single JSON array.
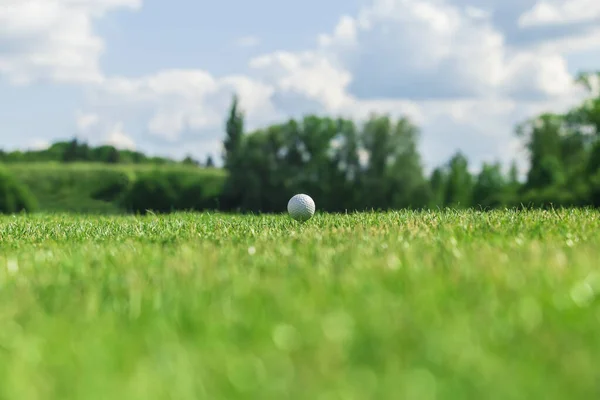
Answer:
[{"xmin": 0, "ymin": 0, "xmax": 600, "ymax": 170}]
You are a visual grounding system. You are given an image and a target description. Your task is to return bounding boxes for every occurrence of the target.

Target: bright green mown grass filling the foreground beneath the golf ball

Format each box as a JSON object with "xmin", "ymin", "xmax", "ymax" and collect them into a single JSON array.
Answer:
[{"xmin": 0, "ymin": 211, "xmax": 600, "ymax": 400}]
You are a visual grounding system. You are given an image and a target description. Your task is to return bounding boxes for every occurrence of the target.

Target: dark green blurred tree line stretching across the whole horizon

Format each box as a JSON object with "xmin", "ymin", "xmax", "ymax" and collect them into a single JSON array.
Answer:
[{"xmin": 0, "ymin": 73, "xmax": 600, "ymax": 212}]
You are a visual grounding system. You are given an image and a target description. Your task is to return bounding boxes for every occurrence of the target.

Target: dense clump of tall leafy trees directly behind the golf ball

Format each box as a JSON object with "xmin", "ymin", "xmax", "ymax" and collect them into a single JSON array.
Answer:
[{"xmin": 229, "ymin": 115, "xmax": 429, "ymax": 212}]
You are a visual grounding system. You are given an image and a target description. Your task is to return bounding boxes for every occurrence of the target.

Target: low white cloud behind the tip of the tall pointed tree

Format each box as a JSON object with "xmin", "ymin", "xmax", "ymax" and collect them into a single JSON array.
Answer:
[{"xmin": 80, "ymin": 70, "xmax": 273, "ymax": 142}]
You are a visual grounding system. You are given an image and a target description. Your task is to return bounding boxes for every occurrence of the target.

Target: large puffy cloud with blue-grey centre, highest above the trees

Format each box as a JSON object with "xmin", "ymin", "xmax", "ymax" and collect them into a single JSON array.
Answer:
[{"xmin": 320, "ymin": 0, "xmax": 573, "ymax": 100}]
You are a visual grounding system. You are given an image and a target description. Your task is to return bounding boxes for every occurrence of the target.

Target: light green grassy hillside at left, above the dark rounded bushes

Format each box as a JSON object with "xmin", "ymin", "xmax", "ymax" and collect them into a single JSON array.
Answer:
[{"xmin": 5, "ymin": 162, "xmax": 225, "ymax": 214}]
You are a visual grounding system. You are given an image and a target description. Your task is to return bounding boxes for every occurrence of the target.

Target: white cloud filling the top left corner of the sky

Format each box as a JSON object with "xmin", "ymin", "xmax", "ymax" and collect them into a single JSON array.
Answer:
[{"xmin": 0, "ymin": 0, "xmax": 142, "ymax": 84}]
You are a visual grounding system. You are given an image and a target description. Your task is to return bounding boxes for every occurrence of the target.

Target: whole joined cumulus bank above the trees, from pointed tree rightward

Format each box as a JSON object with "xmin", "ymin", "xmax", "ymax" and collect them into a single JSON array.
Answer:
[{"xmin": 76, "ymin": 0, "xmax": 592, "ymax": 165}]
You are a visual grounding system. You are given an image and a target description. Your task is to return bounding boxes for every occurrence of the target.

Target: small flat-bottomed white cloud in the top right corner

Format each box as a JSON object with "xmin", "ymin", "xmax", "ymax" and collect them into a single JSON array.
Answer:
[{"xmin": 519, "ymin": 0, "xmax": 600, "ymax": 27}]
